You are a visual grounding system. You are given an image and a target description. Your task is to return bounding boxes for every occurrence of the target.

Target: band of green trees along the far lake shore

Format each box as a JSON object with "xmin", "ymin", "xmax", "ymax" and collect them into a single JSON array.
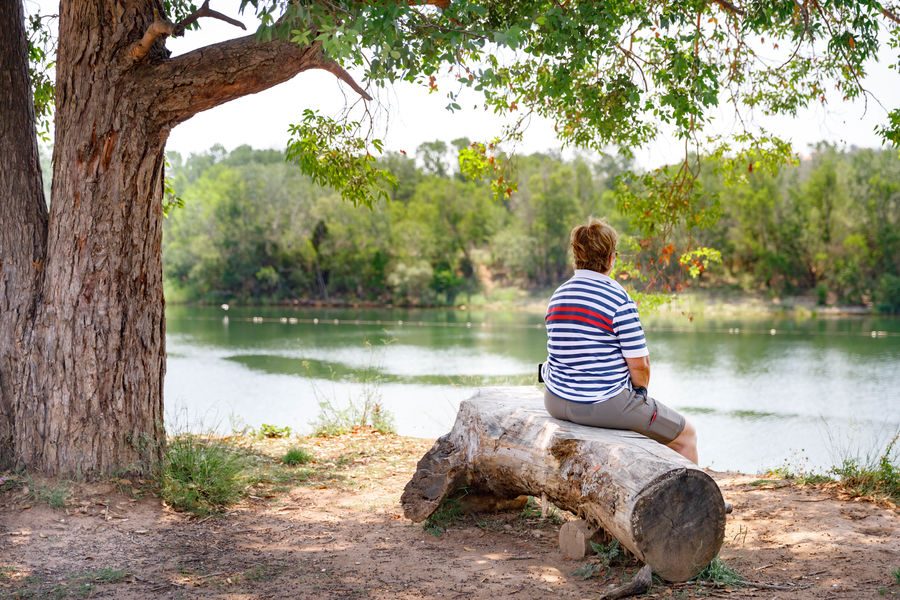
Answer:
[{"xmin": 163, "ymin": 139, "xmax": 900, "ymax": 311}]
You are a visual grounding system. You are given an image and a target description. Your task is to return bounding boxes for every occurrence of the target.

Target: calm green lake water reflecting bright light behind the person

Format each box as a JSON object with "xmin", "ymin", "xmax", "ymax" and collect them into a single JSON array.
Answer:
[{"xmin": 165, "ymin": 306, "xmax": 900, "ymax": 472}]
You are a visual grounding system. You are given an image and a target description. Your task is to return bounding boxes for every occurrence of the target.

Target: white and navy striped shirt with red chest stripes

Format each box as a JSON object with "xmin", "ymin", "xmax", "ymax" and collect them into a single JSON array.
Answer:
[{"xmin": 542, "ymin": 269, "xmax": 650, "ymax": 402}]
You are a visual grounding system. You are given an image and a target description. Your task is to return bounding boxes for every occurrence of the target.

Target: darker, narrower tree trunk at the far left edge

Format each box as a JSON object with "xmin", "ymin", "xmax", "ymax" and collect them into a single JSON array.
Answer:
[{"xmin": 0, "ymin": 0, "xmax": 47, "ymax": 469}]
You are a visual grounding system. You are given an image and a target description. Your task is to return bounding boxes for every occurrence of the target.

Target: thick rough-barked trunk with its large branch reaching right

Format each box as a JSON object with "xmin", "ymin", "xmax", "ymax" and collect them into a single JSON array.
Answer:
[{"xmin": 0, "ymin": 0, "xmax": 323, "ymax": 476}]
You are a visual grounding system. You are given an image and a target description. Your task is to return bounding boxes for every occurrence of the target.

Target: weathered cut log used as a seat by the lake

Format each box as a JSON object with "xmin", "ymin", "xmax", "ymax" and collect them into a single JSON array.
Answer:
[{"xmin": 401, "ymin": 387, "xmax": 725, "ymax": 581}]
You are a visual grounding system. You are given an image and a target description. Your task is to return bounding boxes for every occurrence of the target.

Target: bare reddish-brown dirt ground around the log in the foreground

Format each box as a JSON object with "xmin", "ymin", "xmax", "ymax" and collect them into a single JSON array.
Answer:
[{"xmin": 0, "ymin": 434, "xmax": 900, "ymax": 600}]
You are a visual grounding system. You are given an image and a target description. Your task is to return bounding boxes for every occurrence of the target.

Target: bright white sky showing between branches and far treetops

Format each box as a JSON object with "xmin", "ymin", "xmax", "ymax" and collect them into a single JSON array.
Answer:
[{"xmin": 27, "ymin": 0, "xmax": 900, "ymax": 168}]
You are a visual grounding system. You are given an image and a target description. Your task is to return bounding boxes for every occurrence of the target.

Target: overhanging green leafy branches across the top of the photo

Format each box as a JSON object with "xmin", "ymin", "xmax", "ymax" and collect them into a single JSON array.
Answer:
[{"xmin": 30, "ymin": 0, "xmax": 900, "ymax": 225}]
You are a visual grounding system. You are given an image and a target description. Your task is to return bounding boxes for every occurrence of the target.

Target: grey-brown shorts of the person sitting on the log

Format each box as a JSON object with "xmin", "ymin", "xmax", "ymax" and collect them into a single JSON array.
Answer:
[{"xmin": 544, "ymin": 388, "xmax": 684, "ymax": 444}]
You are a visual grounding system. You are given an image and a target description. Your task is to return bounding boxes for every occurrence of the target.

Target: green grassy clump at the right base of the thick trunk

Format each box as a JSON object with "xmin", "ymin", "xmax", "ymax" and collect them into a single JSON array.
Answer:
[{"xmin": 159, "ymin": 435, "xmax": 245, "ymax": 516}]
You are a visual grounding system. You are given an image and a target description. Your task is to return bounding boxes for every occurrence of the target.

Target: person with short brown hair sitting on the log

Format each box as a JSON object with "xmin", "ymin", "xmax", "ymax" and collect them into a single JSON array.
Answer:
[{"xmin": 541, "ymin": 219, "xmax": 697, "ymax": 463}]
